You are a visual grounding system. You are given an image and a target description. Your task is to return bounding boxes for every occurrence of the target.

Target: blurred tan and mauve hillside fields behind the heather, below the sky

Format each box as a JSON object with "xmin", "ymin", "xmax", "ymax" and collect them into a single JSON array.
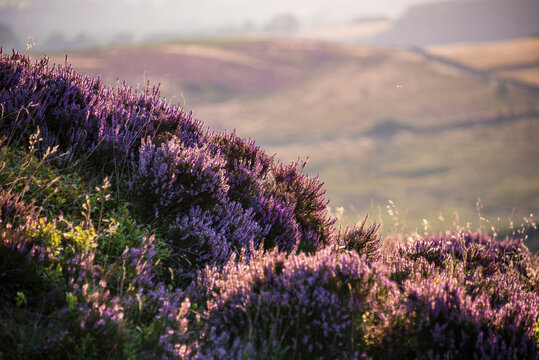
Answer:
[{"xmin": 40, "ymin": 38, "xmax": 539, "ymax": 248}]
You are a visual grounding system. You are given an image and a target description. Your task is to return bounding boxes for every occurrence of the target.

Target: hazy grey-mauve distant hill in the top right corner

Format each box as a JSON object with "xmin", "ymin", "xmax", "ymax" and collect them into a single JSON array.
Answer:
[{"xmin": 372, "ymin": 0, "xmax": 539, "ymax": 46}]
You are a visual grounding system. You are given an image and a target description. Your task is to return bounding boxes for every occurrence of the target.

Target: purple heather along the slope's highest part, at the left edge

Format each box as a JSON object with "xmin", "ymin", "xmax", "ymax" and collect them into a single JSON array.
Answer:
[{"xmin": 0, "ymin": 48, "xmax": 204, "ymax": 173}]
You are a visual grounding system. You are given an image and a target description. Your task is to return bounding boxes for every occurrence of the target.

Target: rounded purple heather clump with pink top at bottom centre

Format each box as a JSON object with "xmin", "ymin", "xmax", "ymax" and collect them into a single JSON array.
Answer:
[{"xmin": 191, "ymin": 248, "xmax": 396, "ymax": 359}]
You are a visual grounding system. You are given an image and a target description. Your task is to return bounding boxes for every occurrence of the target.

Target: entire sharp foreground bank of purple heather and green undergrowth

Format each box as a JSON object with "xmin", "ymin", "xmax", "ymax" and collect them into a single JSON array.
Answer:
[{"xmin": 0, "ymin": 53, "xmax": 539, "ymax": 359}]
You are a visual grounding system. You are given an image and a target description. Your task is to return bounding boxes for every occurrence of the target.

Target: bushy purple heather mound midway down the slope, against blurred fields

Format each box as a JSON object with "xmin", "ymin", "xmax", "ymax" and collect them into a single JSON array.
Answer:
[{"xmin": 131, "ymin": 128, "xmax": 340, "ymax": 264}]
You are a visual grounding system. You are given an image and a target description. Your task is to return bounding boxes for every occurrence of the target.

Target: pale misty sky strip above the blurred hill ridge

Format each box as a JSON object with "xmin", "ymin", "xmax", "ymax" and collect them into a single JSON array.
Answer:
[{"xmin": 0, "ymin": 0, "xmax": 440, "ymax": 40}]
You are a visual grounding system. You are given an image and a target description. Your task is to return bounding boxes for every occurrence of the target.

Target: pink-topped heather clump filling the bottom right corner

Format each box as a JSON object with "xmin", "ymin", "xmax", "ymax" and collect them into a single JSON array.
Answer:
[{"xmin": 380, "ymin": 231, "xmax": 539, "ymax": 359}]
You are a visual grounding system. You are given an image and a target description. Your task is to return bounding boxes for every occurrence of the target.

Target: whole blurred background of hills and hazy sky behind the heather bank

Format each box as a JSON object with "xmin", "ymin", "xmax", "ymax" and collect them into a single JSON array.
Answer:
[{"xmin": 0, "ymin": 0, "xmax": 539, "ymax": 249}]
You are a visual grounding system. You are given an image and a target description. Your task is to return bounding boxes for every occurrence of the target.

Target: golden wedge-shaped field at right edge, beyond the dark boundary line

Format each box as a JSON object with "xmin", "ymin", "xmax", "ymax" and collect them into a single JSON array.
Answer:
[{"xmin": 428, "ymin": 37, "xmax": 539, "ymax": 86}]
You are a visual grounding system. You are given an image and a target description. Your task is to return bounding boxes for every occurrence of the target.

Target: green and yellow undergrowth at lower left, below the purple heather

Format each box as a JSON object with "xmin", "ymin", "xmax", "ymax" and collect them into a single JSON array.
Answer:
[{"xmin": 0, "ymin": 139, "xmax": 168, "ymax": 359}]
